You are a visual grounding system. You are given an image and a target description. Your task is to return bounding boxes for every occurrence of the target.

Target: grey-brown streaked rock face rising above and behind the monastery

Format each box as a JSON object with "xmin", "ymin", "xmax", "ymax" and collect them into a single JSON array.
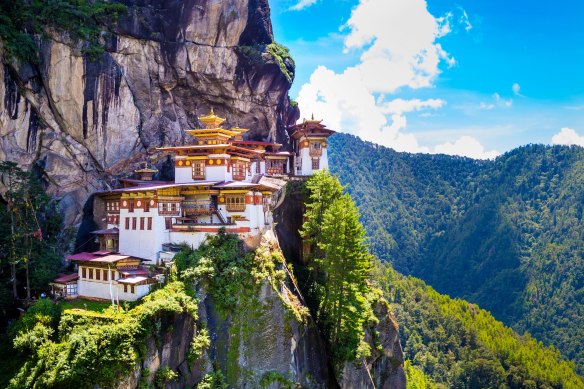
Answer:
[{"xmin": 0, "ymin": 0, "xmax": 299, "ymax": 225}]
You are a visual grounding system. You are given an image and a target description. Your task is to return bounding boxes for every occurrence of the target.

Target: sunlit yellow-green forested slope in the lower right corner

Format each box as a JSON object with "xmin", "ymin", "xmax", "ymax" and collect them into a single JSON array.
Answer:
[{"xmin": 374, "ymin": 263, "xmax": 584, "ymax": 388}]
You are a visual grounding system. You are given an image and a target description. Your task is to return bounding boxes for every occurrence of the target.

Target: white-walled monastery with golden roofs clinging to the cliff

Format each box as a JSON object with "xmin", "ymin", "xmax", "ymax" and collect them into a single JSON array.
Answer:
[{"xmin": 51, "ymin": 109, "xmax": 334, "ymax": 302}]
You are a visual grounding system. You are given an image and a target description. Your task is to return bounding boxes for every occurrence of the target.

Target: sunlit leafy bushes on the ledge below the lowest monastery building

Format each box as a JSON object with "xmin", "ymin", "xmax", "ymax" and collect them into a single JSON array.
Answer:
[{"xmin": 8, "ymin": 282, "xmax": 197, "ymax": 388}]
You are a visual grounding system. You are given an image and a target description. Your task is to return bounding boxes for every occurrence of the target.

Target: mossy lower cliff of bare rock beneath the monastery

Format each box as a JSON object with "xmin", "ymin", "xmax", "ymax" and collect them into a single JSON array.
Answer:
[{"xmin": 118, "ymin": 234, "xmax": 405, "ymax": 389}]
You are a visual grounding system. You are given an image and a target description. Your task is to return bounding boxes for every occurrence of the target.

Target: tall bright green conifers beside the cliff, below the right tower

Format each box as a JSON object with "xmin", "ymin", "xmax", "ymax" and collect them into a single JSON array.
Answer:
[{"xmin": 301, "ymin": 171, "xmax": 376, "ymax": 363}]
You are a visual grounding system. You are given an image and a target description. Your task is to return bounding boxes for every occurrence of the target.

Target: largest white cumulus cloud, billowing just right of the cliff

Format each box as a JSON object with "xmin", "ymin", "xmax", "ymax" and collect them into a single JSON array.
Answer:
[{"xmin": 297, "ymin": 0, "xmax": 492, "ymax": 158}]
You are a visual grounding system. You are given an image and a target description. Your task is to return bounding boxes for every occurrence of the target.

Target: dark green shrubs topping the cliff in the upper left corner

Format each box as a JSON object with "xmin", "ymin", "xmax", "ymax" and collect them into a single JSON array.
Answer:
[{"xmin": 0, "ymin": 0, "xmax": 126, "ymax": 63}]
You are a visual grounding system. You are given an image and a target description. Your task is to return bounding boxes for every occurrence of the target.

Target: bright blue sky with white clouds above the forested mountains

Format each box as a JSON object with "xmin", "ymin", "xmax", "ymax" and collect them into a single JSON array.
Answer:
[{"xmin": 270, "ymin": 0, "xmax": 584, "ymax": 159}]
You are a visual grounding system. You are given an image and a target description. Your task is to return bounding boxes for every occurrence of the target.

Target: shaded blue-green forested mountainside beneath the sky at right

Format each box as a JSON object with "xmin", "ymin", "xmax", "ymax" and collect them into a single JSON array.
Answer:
[{"xmin": 329, "ymin": 134, "xmax": 584, "ymax": 373}]
